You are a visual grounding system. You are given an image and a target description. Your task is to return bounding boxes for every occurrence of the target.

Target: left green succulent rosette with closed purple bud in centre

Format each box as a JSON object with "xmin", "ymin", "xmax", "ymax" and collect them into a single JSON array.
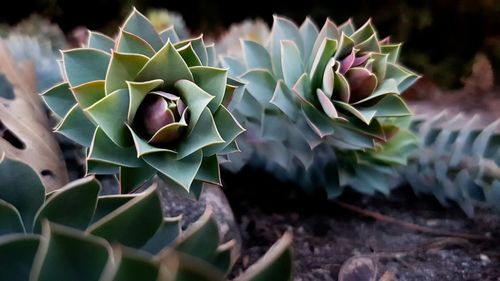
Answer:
[{"xmin": 42, "ymin": 9, "xmax": 244, "ymax": 192}]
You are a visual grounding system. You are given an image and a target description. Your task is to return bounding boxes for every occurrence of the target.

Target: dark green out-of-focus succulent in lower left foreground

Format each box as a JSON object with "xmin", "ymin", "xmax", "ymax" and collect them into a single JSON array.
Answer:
[{"xmin": 0, "ymin": 158, "xmax": 292, "ymax": 281}]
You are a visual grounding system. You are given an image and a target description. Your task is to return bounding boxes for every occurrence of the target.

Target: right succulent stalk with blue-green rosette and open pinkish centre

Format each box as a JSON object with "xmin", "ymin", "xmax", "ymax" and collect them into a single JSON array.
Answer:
[{"xmin": 221, "ymin": 16, "xmax": 418, "ymax": 197}]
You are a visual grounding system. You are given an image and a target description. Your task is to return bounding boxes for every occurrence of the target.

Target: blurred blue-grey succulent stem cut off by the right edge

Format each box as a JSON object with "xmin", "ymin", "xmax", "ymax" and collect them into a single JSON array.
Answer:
[{"xmin": 401, "ymin": 112, "xmax": 500, "ymax": 216}]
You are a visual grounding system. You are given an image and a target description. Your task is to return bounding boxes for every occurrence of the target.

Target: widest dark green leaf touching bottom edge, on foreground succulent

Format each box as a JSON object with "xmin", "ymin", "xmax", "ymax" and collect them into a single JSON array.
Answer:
[{"xmin": 30, "ymin": 222, "xmax": 112, "ymax": 281}]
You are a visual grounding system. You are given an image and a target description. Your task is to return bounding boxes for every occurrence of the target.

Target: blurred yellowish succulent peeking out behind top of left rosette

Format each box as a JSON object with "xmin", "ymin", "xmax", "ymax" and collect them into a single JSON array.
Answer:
[{"xmin": 146, "ymin": 9, "xmax": 190, "ymax": 40}]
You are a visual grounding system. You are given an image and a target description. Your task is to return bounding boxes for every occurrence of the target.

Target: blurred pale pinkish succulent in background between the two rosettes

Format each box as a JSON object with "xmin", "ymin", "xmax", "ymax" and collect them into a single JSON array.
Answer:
[{"xmin": 215, "ymin": 19, "xmax": 270, "ymax": 57}]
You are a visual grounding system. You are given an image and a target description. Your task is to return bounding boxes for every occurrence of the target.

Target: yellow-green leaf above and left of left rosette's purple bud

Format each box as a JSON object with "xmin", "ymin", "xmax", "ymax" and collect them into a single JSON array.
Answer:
[{"xmin": 105, "ymin": 52, "xmax": 149, "ymax": 95}]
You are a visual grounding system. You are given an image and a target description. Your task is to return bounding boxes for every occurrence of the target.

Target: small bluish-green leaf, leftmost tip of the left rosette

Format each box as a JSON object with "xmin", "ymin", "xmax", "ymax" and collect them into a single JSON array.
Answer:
[{"xmin": 42, "ymin": 83, "xmax": 76, "ymax": 118}]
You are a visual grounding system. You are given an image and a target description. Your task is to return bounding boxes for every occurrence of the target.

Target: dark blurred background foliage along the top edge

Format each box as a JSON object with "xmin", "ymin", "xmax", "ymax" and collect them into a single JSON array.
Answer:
[{"xmin": 0, "ymin": 0, "xmax": 500, "ymax": 89}]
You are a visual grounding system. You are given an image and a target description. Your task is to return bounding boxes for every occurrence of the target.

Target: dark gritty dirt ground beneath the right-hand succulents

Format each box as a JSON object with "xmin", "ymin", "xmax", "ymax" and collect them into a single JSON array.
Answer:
[{"xmin": 223, "ymin": 170, "xmax": 500, "ymax": 281}]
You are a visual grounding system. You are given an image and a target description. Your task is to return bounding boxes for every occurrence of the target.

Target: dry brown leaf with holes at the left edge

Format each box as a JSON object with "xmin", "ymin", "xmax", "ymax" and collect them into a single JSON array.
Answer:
[{"xmin": 0, "ymin": 43, "xmax": 68, "ymax": 192}]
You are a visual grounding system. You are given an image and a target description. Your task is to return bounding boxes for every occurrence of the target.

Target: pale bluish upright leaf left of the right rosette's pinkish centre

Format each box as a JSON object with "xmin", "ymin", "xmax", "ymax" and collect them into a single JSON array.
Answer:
[{"xmin": 281, "ymin": 40, "xmax": 304, "ymax": 87}]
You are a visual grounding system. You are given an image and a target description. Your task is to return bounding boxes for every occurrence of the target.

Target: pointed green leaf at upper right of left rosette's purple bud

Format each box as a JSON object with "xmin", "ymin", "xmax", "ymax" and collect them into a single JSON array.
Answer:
[{"xmin": 190, "ymin": 66, "xmax": 227, "ymax": 113}]
